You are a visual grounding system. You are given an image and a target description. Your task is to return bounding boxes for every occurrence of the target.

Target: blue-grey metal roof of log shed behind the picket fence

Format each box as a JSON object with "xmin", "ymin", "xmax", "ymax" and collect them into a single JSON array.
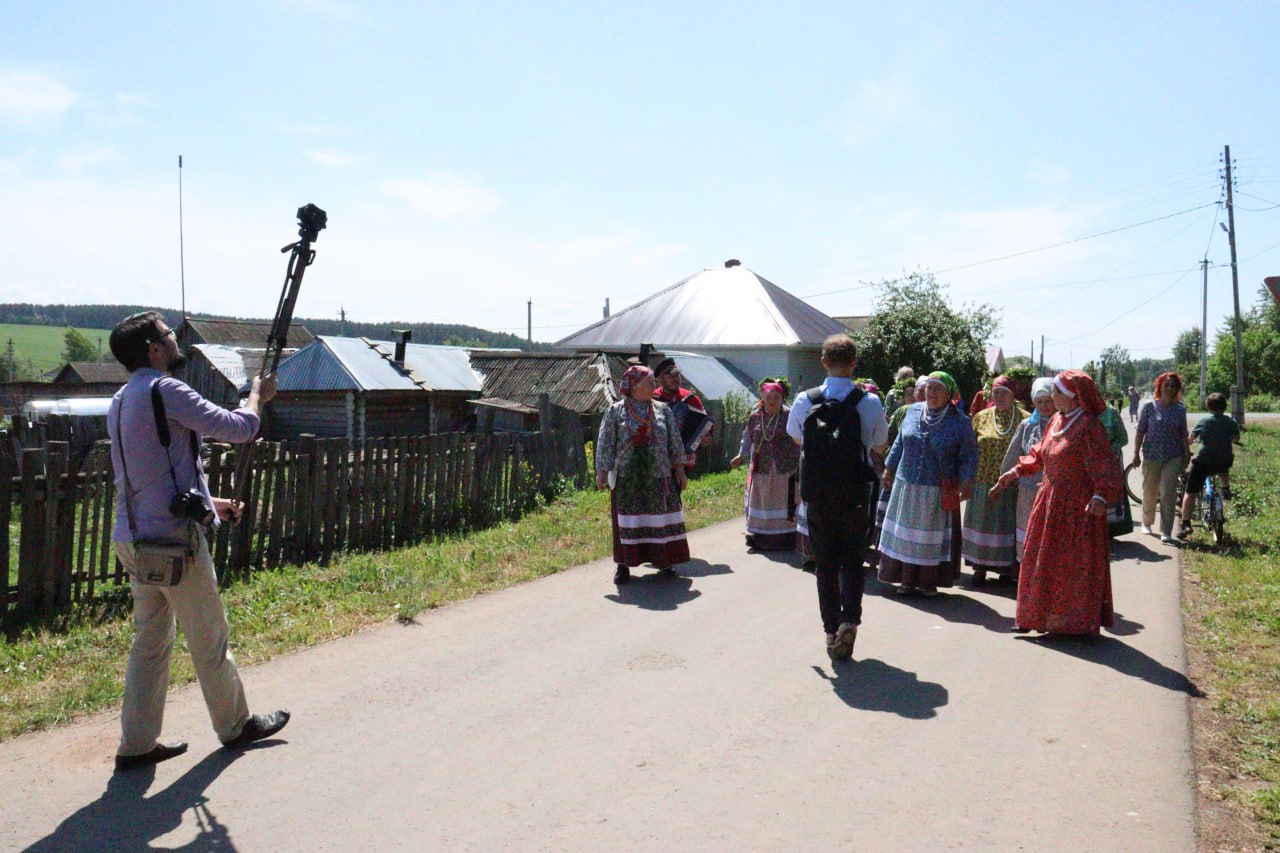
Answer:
[{"xmin": 278, "ymin": 334, "xmax": 483, "ymax": 393}]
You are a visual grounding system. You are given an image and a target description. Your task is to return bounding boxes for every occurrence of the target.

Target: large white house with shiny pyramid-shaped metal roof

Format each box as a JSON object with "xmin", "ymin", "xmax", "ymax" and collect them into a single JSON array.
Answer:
[{"xmin": 557, "ymin": 260, "xmax": 847, "ymax": 388}]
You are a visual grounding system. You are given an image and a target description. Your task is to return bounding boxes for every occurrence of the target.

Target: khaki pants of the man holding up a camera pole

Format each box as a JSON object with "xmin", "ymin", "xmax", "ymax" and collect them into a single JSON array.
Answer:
[{"xmin": 115, "ymin": 533, "xmax": 248, "ymax": 756}]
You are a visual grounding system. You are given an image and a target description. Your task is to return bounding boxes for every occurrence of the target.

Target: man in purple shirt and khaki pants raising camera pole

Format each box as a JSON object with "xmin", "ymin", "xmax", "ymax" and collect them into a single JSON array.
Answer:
[{"xmin": 106, "ymin": 311, "xmax": 289, "ymax": 770}]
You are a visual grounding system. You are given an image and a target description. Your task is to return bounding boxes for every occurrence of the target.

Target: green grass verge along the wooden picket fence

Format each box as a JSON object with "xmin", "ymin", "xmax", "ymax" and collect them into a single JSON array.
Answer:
[{"xmin": 0, "ymin": 469, "xmax": 746, "ymax": 740}]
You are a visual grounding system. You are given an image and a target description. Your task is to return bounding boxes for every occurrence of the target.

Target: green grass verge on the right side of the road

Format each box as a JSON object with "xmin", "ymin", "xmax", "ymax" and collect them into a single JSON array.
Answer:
[{"xmin": 1183, "ymin": 425, "xmax": 1280, "ymax": 848}]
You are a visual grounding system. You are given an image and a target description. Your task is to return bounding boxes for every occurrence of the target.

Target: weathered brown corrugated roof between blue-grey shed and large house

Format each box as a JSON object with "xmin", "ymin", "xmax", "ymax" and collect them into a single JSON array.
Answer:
[{"xmin": 471, "ymin": 350, "xmax": 617, "ymax": 414}]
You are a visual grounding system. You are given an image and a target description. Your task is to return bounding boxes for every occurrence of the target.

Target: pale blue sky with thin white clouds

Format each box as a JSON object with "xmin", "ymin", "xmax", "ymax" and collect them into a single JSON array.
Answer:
[{"xmin": 0, "ymin": 0, "xmax": 1280, "ymax": 366}]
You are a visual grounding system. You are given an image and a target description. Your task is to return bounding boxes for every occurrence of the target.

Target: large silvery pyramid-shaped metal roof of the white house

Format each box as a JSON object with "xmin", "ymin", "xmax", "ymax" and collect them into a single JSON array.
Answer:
[{"xmin": 558, "ymin": 266, "xmax": 845, "ymax": 348}]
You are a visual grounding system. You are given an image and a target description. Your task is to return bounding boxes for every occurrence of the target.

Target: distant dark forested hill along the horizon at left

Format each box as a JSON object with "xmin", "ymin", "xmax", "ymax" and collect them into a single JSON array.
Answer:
[{"xmin": 0, "ymin": 302, "xmax": 550, "ymax": 351}]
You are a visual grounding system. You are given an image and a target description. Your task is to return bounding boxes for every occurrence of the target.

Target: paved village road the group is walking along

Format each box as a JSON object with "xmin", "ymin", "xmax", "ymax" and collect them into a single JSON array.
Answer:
[{"xmin": 0, "ymin": 417, "xmax": 1196, "ymax": 850}]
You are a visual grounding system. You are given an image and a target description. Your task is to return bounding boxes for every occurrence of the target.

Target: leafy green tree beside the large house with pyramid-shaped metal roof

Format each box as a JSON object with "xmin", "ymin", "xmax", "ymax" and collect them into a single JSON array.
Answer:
[{"xmin": 854, "ymin": 273, "xmax": 1000, "ymax": 397}]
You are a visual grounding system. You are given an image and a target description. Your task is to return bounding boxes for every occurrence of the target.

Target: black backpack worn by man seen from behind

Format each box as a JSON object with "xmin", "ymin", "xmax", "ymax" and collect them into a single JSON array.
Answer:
[{"xmin": 800, "ymin": 387, "xmax": 876, "ymax": 514}]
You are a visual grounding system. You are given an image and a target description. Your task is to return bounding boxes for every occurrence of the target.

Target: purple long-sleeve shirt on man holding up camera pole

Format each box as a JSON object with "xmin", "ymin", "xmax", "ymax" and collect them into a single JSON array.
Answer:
[{"xmin": 106, "ymin": 368, "xmax": 260, "ymax": 542}]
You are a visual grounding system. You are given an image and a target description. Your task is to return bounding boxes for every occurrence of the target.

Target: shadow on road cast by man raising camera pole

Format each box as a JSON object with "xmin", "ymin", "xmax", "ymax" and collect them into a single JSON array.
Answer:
[{"xmin": 27, "ymin": 739, "xmax": 287, "ymax": 853}]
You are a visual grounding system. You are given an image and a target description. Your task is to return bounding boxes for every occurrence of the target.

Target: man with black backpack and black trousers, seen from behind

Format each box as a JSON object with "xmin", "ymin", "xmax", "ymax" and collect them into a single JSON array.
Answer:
[{"xmin": 787, "ymin": 334, "xmax": 888, "ymax": 661}]
